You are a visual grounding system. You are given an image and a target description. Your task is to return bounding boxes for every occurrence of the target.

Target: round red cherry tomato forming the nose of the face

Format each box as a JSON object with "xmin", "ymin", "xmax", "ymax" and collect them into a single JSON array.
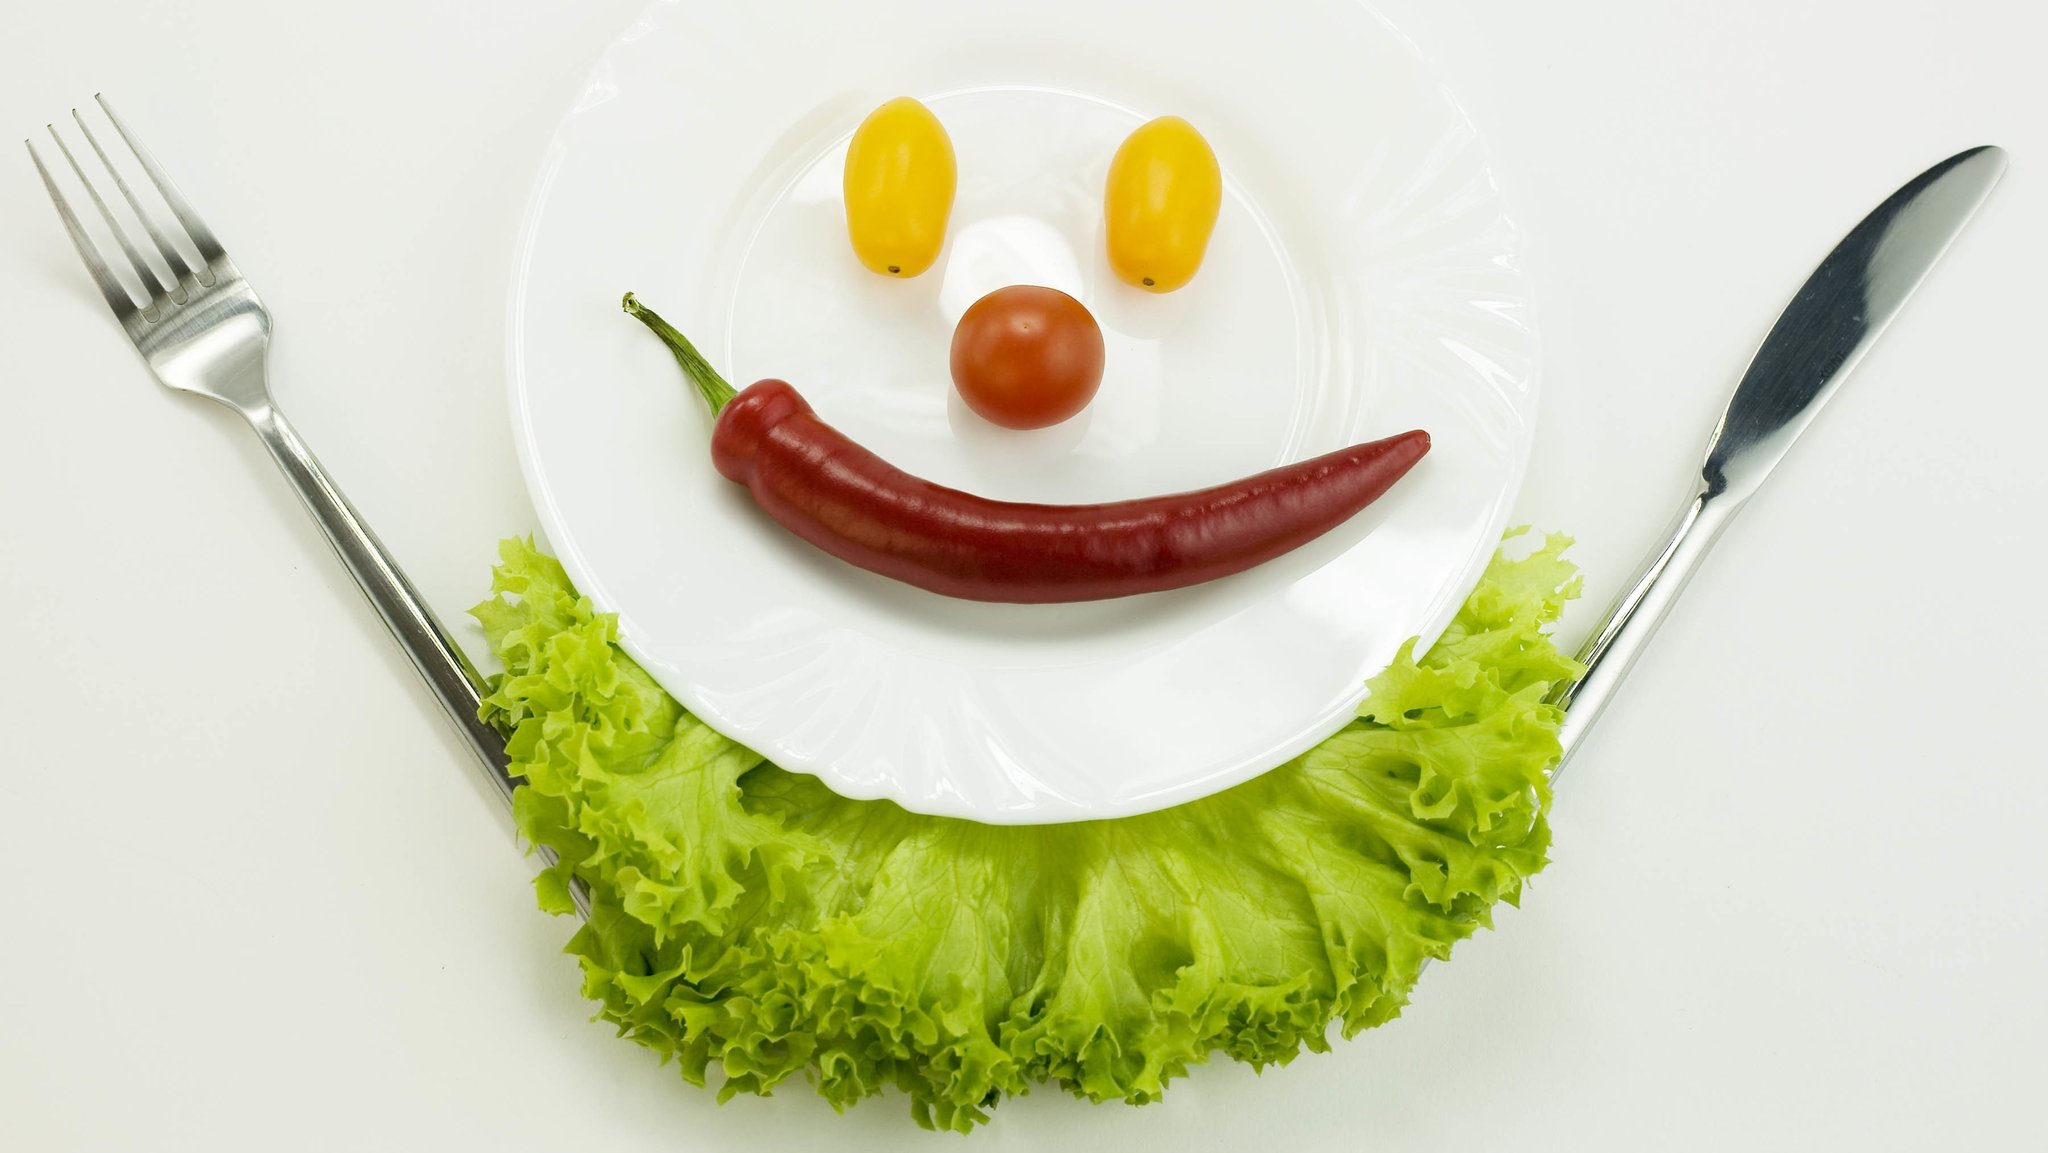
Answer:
[{"xmin": 952, "ymin": 285, "xmax": 1102, "ymax": 428}]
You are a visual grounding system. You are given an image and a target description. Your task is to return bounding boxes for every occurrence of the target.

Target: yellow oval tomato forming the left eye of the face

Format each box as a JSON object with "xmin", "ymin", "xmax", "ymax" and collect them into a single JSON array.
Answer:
[{"xmin": 846, "ymin": 96, "xmax": 958, "ymax": 276}]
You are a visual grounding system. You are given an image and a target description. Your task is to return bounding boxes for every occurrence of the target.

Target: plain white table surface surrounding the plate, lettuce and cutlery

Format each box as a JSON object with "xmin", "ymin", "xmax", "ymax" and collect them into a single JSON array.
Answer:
[{"xmin": 0, "ymin": 0, "xmax": 2048, "ymax": 1151}]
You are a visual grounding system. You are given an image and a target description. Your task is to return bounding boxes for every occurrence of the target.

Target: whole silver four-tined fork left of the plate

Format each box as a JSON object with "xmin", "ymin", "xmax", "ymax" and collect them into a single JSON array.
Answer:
[{"xmin": 25, "ymin": 94, "xmax": 590, "ymax": 917}]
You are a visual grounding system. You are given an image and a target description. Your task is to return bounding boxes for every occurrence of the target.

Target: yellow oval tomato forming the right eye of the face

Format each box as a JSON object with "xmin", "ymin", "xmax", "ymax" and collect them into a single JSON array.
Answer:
[{"xmin": 1102, "ymin": 117, "xmax": 1223, "ymax": 293}]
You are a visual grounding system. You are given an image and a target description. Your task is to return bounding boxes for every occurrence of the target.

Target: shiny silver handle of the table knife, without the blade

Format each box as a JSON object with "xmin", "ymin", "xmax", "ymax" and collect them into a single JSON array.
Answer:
[{"xmin": 1548, "ymin": 477, "xmax": 1743, "ymax": 782}]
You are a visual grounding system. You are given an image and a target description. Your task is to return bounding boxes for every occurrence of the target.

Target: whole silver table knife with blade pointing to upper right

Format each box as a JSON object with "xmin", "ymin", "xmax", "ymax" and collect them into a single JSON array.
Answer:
[{"xmin": 1550, "ymin": 145, "xmax": 2005, "ymax": 780}]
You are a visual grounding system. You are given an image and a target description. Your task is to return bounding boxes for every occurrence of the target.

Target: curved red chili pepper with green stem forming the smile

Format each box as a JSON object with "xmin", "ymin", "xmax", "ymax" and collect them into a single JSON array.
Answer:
[{"xmin": 625, "ymin": 293, "xmax": 1430, "ymax": 604}]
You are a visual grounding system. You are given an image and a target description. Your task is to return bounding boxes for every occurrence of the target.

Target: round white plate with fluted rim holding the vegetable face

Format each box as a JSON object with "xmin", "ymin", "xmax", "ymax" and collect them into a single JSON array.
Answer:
[{"xmin": 510, "ymin": 0, "xmax": 1536, "ymax": 823}]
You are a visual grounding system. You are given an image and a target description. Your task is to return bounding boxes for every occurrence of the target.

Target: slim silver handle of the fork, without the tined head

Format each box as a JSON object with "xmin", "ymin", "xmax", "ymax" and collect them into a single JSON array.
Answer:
[{"xmin": 242, "ymin": 405, "xmax": 590, "ymax": 917}]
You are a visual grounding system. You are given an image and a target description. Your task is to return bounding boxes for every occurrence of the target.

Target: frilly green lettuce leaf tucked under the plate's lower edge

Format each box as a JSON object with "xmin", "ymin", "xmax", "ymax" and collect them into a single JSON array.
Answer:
[{"xmin": 473, "ymin": 537, "xmax": 1579, "ymax": 1133}]
